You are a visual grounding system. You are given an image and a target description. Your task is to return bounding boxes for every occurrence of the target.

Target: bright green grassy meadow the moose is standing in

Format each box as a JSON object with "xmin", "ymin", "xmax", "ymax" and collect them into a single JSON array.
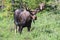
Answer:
[{"xmin": 0, "ymin": 11, "xmax": 60, "ymax": 40}]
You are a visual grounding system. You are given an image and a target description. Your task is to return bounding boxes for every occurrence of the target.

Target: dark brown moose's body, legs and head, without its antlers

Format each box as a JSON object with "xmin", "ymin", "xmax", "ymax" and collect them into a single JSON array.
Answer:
[{"xmin": 14, "ymin": 9, "xmax": 37, "ymax": 33}]
